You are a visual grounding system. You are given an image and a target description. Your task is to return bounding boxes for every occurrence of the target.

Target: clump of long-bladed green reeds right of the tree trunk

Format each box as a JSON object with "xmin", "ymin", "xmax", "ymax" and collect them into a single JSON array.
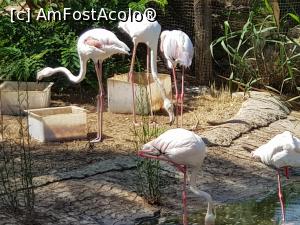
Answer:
[{"xmin": 211, "ymin": 8, "xmax": 300, "ymax": 98}]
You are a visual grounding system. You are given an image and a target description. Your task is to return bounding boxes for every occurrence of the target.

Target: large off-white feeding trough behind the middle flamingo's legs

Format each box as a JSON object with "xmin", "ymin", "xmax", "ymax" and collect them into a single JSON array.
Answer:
[{"xmin": 107, "ymin": 73, "xmax": 172, "ymax": 114}]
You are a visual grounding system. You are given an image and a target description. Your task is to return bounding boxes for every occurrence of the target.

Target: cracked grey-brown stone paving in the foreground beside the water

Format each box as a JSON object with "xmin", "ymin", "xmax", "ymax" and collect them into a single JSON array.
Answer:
[{"xmin": 0, "ymin": 92, "xmax": 300, "ymax": 225}]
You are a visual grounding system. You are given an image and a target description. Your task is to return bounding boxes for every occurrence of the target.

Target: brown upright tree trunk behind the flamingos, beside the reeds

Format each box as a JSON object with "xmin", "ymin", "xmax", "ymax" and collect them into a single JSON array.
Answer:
[{"xmin": 194, "ymin": 0, "xmax": 212, "ymax": 85}]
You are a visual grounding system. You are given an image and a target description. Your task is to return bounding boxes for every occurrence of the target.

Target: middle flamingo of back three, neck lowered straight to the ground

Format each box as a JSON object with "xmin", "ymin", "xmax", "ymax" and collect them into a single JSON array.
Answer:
[{"xmin": 119, "ymin": 14, "xmax": 174, "ymax": 125}]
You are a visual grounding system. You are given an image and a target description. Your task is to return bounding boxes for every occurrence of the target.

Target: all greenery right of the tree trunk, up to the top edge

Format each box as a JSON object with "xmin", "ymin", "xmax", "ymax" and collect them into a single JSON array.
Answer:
[{"xmin": 211, "ymin": 0, "xmax": 300, "ymax": 100}]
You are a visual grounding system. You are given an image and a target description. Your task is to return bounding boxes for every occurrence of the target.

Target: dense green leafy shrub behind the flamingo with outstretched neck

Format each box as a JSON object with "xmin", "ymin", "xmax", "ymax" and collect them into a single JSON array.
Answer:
[{"xmin": 0, "ymin": 0, "xmax": 166, "ymax": 87}]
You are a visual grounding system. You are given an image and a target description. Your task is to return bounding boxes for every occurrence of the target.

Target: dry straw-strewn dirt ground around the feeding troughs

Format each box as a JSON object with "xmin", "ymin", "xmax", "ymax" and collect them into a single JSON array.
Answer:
[{"xmin": 3, "ymin": 88, "xmax": 243, "ymax": 176}]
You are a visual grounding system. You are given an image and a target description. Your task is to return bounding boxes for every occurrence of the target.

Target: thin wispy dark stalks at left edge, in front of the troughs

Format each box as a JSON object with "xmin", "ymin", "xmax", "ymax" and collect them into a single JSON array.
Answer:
[{"xmin": 0, "ymin": 81, "xmax": 35, "ymax": 221}]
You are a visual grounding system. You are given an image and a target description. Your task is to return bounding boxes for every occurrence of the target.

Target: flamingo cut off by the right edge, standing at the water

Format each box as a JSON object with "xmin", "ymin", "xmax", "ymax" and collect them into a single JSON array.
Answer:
[{"xmin": 251, "ymin": 131, "xmax": 300, "ymax": 222}]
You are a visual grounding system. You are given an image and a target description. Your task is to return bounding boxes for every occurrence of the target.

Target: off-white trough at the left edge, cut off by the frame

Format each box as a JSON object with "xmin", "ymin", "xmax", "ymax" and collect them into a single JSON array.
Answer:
[{"xmin": 0, "ymin": 81, "xmax": 53, "ymax": 115}]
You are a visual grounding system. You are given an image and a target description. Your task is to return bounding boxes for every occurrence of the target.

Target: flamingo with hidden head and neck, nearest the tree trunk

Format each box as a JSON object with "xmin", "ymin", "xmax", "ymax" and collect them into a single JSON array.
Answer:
[{"xmin": 160, "ymin": 30, "xmax": 194, "ymax": 127}]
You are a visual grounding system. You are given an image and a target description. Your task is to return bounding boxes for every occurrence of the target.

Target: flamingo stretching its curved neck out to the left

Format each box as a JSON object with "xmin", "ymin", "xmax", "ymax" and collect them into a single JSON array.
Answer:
[{"xmin": 36, "ymin": 28, "xmax": 130, "ymax": 143}]
